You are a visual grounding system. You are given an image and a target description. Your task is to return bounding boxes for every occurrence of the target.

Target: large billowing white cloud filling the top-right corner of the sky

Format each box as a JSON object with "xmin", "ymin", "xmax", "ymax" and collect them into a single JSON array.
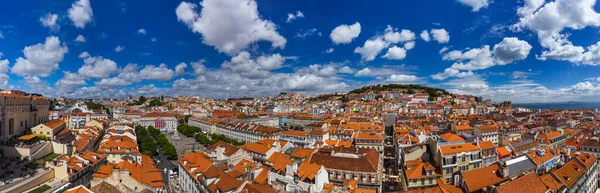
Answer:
[{"xmin": 511, "ymin": 0, "xmax": 600, "ymax": 65}]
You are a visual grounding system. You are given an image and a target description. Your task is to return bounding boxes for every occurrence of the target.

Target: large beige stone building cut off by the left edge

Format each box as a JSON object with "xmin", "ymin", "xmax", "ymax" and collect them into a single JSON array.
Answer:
[{"xmin": 0, "ymin": 90, "xmax": 50, "ymax": 141}]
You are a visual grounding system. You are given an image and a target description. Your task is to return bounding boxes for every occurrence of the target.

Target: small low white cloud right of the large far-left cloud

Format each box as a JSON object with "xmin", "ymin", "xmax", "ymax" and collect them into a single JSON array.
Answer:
[{"xmin": 77, "ymin": 56, "xmax": 119, "ymax": 78}]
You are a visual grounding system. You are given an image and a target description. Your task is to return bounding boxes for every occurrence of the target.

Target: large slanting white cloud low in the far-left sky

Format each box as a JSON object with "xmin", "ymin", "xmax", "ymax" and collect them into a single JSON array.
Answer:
[{"xmin": 11, "ymin": 36, "xmax": 69, "ymax": 77}]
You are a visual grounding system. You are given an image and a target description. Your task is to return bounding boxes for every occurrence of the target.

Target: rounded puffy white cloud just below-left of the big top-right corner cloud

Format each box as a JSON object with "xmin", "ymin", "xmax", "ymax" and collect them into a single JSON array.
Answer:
[{"xmin": 494, "ymin": 37, "xmax": 531, "ymax": 64}]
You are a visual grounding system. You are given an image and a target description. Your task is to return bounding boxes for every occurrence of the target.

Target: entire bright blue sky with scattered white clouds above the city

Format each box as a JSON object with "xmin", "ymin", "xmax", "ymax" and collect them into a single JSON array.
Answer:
[{"xmin": 0, "ymin": 0, "xmax": 600, "ymax": 103}]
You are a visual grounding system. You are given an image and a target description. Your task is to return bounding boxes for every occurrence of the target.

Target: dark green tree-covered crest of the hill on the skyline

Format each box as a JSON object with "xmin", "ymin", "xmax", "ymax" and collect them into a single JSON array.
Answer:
[{"xmin": 348, "ymin": 84, "xmax": 449, "ymax": 97}]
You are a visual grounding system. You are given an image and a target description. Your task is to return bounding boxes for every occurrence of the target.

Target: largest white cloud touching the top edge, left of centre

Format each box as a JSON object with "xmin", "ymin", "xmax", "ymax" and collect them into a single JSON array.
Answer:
[{"xmin": 175, "ymin": 0, "xmax": 286, "ymax": 56}]
